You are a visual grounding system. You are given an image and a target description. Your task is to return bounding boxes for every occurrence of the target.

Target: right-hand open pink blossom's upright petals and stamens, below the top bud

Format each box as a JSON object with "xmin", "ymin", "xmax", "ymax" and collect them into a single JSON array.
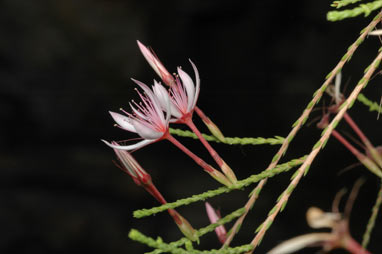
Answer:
[{"xmin": 153, "ymin": 60, "xmax": 200, "ymax": 122}]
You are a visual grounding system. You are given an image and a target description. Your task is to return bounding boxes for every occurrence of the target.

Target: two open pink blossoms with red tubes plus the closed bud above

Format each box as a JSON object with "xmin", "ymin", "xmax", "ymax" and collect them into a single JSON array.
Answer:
[{"xmin": 103, "ymin": 41, "xmax": 236, "ymax": 186}]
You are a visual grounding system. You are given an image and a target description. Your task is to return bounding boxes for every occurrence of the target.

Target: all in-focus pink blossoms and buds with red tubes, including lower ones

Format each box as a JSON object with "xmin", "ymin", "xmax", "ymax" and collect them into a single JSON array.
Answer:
[{"xmin": 102, "ymin": 41, "xmax": 237, "ymax": 242}]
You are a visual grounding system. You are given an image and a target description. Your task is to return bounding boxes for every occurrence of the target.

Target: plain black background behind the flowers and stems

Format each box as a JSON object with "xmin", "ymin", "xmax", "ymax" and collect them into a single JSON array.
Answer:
[{"xmin": 0, "ymin": 0, "xmax": 382, "ymax": 254}]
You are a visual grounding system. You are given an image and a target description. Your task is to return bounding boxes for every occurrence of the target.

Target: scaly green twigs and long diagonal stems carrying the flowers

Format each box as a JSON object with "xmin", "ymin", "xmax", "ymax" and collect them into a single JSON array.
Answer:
[{"xmin": 129, "ymin": 6, "xmax": 382, "ymax": 254}]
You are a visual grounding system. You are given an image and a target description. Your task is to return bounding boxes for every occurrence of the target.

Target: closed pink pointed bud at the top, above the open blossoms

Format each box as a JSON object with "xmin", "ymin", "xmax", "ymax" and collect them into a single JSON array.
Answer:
[{"xmin": 137, "ymin": 40, "xmax": 175, "ymax": 86}]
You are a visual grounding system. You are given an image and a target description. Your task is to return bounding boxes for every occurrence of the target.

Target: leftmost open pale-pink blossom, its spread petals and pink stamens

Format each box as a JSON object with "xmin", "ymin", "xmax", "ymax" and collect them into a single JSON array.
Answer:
[{"xmin": 103, "ymin": 80, "xmax": 171, "ymax": 150}]
